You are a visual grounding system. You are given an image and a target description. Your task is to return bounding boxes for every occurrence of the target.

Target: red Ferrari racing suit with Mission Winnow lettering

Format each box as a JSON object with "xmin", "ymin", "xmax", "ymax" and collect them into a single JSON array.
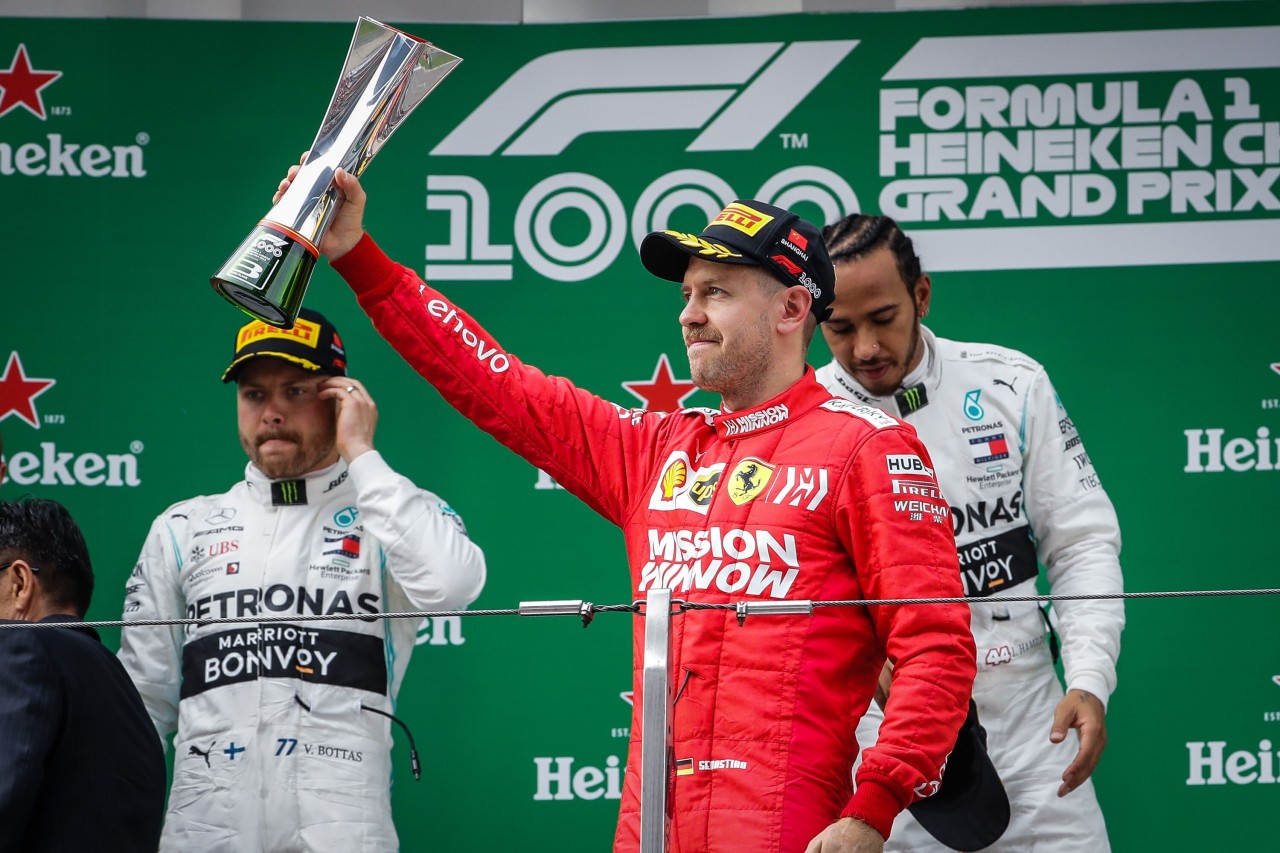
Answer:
[{"xmin": 333, "ymin": 236, "xmax": 975, "ymax": 853}]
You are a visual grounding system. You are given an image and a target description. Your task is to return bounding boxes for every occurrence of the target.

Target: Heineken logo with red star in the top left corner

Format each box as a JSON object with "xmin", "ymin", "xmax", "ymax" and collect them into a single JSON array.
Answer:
[{"xmin": 0, "ymin": 44, "xmax": 151, "ymax": 178}]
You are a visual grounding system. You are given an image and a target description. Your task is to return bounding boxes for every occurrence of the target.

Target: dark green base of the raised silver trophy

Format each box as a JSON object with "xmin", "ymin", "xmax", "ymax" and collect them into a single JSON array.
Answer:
[{"xmin": 209, "ymin": 222, "xmax": 319, "ymax": 329}]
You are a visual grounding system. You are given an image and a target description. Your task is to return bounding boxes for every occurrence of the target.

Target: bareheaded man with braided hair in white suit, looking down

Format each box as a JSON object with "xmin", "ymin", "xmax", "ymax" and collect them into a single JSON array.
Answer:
[{"xmin": 818, "ymin": 214, "xmax": 1124, "ymax": 853}]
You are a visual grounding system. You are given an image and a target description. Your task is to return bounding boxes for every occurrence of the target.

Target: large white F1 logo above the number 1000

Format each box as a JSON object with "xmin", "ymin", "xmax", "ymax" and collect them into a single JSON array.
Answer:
[{"xmin": 431, "ymin": 41, "xmax": 858, "ymax": 156}]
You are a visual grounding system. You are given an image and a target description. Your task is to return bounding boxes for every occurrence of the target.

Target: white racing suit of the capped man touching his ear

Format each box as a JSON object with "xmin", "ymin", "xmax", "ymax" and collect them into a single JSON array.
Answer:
[{"xmin": 120, "ymin": 451, "xmax": 485, "ymax": 853}]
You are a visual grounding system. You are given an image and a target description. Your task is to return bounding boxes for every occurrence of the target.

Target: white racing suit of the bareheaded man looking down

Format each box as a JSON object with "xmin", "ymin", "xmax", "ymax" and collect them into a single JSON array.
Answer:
[{"xmin": 818, "ymin": 327, "xmax": 1124, "ymax": 853}]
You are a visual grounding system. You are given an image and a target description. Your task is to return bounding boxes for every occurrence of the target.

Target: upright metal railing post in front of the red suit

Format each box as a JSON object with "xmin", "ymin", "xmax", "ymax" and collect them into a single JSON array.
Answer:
[{"xmin": 640, "ymin": 589, "xmax": 675, "ymax": 853}]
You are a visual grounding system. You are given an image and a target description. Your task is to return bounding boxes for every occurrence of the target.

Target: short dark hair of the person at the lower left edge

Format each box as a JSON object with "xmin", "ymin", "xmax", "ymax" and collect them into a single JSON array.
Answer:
[{"xmin": 0, "ymin": 498, "xmax": 93, "ymax": 616}]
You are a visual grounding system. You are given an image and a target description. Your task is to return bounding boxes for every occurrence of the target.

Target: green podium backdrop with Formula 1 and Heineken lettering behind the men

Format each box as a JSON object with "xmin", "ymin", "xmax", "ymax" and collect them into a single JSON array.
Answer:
[{"xmin": 0, "ymin": 3, "xmax": 1280, "ymax": 852}]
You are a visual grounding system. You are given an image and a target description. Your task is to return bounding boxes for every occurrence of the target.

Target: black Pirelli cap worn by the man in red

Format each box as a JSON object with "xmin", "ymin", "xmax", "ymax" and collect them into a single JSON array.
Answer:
[{"xmin": 640, "ymin": 199, "xmax": 836, "ymax": 321}]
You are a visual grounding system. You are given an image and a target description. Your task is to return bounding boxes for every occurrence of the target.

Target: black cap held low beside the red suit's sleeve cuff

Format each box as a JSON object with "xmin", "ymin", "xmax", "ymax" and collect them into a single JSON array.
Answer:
[{"xmin": 908, "ymin": 699, "xmax": 1010, "ymax": 850}]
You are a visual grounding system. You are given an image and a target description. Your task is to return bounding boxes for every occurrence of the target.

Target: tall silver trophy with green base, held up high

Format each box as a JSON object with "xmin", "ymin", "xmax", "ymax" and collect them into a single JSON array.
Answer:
[{"xmin": 209, "ymin": 17, "xmax": 462, "ymax": 329}]
